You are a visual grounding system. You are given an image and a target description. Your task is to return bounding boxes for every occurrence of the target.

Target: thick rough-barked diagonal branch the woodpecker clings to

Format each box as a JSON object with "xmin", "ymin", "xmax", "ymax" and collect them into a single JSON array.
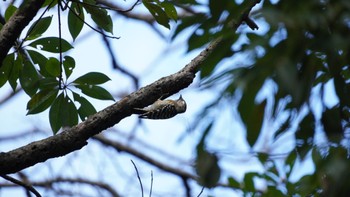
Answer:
[{"xmin": 0, "ymin": 0, "xmax": 260, "ymax": 175}]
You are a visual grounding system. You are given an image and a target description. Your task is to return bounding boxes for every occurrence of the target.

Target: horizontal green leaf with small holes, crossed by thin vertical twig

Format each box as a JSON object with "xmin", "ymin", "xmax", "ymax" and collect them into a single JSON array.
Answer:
[{"xmin": 29, "ymin": 37, "xmax": 73, "ymax": 53}]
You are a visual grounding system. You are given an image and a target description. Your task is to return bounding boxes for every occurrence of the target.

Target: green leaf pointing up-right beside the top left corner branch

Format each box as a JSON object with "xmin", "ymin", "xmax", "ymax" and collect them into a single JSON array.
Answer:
[{"xmin": 26, "ymin": 16, "xmax": 52, "ymax": 40}]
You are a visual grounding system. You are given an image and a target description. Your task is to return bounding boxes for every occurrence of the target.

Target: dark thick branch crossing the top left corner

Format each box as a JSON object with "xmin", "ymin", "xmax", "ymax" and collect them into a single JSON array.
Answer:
[{"xmin": 0, "ymin": 0, "xmax": 45, "ymax": 67}]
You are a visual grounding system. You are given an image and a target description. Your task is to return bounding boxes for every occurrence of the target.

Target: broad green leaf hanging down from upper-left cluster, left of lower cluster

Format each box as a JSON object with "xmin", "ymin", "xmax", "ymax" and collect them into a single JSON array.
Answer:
[{"xmin": 19, "ymin": 61, "xmax": 39, "ymax": 96}]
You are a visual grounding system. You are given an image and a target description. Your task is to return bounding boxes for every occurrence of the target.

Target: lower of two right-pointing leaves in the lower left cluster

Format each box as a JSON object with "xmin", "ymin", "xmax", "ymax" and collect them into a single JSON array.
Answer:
[{"xmin": 75, "ymin": 85, "xmax": 114, "ymax": 101}]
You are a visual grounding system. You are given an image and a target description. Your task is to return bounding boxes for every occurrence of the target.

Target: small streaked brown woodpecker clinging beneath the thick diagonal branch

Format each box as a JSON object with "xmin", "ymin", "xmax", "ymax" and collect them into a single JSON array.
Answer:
[{"xmin": 135, "ymin": 95, "xmax": 186, "ymax": 119}]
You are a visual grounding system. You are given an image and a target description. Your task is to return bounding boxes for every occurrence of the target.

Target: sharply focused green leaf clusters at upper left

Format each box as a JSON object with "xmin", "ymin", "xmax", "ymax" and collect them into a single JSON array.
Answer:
[{"xmin": 0, "ymin": 0, "xmax": 114, "ymax": 134}]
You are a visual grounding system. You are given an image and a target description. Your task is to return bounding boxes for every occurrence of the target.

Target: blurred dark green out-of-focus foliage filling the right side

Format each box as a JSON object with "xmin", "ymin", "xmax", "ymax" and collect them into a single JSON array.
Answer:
[{"xmin": 174, "ymin": 0, "xmax": 350, "ymax": 196}]
